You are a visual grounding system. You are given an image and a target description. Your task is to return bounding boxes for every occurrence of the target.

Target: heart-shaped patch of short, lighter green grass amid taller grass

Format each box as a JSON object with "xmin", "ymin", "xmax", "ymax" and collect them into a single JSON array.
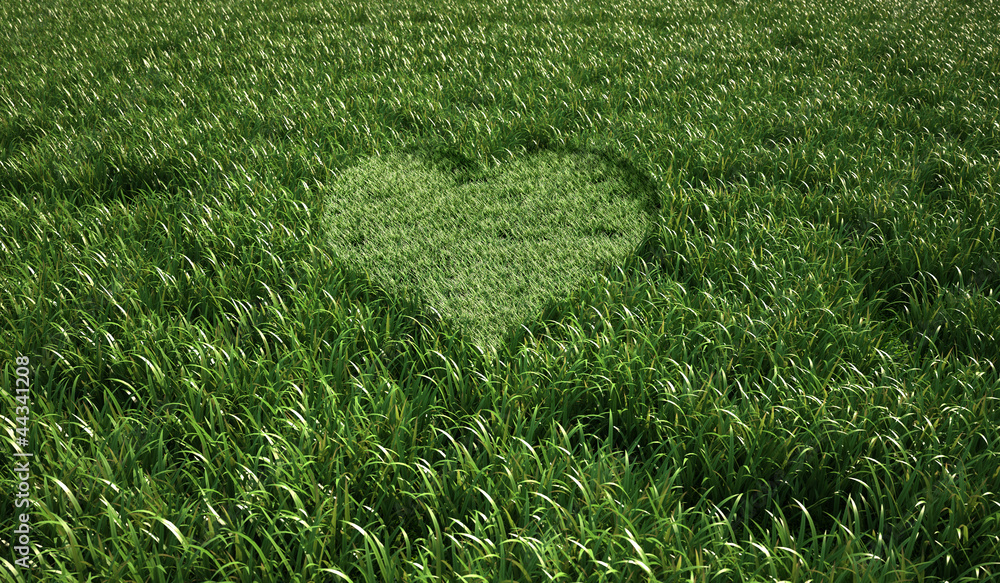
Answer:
[{"xmin": 324, "ymin": 149, "xmax": 658, "ymax": 356}]
